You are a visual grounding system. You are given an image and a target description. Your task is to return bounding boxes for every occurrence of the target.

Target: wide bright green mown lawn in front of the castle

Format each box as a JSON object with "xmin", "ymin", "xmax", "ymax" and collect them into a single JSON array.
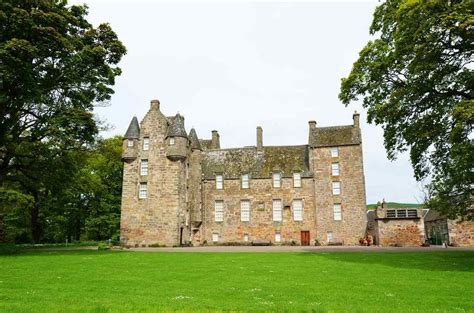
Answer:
[{"xmin": 0, "ymin": 251, "xmax": 474, "ymax": 312}]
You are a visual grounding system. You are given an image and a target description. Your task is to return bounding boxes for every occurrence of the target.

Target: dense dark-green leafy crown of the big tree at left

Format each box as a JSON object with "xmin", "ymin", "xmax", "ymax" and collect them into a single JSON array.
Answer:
[{"xmin": 0, "ymin": 0, "xmax": 126, "ymax": 185}]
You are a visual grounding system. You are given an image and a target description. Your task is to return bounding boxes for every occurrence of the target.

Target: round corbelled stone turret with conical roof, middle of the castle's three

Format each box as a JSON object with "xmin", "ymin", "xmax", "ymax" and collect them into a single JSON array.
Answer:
[{"xmin": 165, "ymin": 113, "xmax": 188, "ymax": 161}]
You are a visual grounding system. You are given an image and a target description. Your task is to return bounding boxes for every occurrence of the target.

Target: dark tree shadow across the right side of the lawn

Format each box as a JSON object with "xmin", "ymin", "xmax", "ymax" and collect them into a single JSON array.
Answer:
[{"xmin": 299, "ymin": 251, "xmax": 474, "ymax": 272}]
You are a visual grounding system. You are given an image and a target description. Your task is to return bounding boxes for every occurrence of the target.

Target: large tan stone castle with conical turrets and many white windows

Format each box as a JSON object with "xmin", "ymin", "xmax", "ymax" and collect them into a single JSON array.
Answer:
[{"xmin": 120, "ymin": 100, "xmax": 367, "ymax": 246}]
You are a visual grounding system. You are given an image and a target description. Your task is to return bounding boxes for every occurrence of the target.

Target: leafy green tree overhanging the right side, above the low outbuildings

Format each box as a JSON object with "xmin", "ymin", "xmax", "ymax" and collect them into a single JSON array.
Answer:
[{"xmin": 339, "ymin": 0, "xmax": 474, "ymax": 219}]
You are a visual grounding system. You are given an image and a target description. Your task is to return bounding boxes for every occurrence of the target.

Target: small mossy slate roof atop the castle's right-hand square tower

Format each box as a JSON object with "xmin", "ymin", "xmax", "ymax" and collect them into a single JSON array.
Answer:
[{"xmin": 309, "ymin": 125, "xmax": 362, "ymax": 148}]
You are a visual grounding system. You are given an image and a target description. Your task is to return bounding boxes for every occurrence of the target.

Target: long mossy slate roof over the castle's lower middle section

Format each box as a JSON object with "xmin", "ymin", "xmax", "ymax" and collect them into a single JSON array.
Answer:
[{"xmin": 201, "ymin": 141, "xmax": 313, "ymax": 179}]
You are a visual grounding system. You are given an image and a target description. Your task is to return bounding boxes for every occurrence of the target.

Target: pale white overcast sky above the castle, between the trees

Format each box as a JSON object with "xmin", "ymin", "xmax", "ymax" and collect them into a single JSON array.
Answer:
[{"xmin": 69, "ymin": 0, "xmax": 423, "ymax": 203}]
